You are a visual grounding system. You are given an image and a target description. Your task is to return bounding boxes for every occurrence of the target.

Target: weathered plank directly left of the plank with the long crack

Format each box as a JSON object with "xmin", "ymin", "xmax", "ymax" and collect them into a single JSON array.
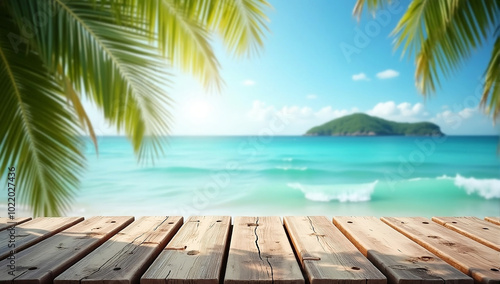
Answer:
[{"xmin": 141, "ymin": 216, "xmax": 231, "ymax": 284}]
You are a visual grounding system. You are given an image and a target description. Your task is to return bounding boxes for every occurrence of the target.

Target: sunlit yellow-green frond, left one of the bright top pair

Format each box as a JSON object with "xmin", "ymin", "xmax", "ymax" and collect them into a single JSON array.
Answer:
[{"xmin": 118, "ymin": 0, "xmax": 223, "ymax": 89}]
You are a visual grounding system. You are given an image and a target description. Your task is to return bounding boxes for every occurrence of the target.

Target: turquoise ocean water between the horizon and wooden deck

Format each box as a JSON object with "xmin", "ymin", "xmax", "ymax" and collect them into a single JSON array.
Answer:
[{"xmin": 60, "ymin": 136, "xmax": 500, "ymax": 217}]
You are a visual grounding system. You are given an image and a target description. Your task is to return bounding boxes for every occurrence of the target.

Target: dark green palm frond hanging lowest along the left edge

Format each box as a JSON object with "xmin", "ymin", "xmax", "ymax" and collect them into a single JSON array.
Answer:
[{"xmin": 0, "ymin": 10, "xmax": 84, "ymax": 216}]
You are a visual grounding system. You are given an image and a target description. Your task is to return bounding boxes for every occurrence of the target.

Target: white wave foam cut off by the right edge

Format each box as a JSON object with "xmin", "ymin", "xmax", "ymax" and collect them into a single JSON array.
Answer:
[{"xmin": 454, "ymin": 174, "xmax": 500, "ymax": 199}]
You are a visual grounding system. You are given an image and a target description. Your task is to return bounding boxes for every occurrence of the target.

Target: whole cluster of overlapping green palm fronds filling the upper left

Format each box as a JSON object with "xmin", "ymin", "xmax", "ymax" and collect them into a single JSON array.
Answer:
[{"xmin": 0, "ymin": 0, "xmax": 268, "ymax": 215}]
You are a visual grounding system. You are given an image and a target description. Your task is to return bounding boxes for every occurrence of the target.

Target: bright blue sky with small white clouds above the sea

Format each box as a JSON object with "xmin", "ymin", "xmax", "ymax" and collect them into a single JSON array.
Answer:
[{"xmin": 89, "ymin": 0, "xmax": 499, "ymax": 135}]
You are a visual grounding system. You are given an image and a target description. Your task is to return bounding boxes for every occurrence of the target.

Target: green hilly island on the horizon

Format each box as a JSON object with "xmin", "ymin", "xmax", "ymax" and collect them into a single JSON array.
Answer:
[{"xmin": 305, "ymin": 113, "xmax": 444, "ymax": 136}]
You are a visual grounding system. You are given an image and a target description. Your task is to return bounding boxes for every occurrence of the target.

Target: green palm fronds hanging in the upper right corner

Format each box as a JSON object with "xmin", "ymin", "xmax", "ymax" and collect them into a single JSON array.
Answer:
[{"xmin": 354, "ymin": 0, "xmax": 500, "ymax": 119}]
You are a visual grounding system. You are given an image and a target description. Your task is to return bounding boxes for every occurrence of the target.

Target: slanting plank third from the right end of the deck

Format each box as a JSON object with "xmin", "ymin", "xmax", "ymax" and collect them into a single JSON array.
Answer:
[{"xmin": 382, "ymin": 217, "xmax": 500, "ymax": 284}]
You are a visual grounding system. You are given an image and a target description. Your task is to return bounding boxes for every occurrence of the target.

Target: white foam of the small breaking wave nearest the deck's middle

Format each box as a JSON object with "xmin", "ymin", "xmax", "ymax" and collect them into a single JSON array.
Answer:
[{"xmin": 287, "ymin": 180, "xmax": 378, "ymax": 202}]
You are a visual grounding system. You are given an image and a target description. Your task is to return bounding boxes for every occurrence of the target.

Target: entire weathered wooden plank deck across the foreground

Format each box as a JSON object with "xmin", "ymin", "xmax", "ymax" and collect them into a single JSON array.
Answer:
[{"xmin": 0, "ymin": 216, "xmax": 500, "ymax": 284}]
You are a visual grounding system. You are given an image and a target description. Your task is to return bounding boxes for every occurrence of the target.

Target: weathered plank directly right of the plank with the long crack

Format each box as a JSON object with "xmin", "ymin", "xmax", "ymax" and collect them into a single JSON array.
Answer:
[{"xmin": 284, "ymin": 216, "xmax": 387, "ymax": 284}]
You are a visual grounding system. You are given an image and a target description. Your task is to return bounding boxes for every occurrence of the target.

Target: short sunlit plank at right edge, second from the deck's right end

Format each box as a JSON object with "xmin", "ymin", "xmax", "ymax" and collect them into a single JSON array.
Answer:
[{"xmin": 432, "ymin": 217, "xmax": 500, "ymax": 251}]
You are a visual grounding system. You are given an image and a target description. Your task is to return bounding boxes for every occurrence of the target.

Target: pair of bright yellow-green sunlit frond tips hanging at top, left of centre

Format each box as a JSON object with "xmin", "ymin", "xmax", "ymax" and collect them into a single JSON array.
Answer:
[{"xmin": 125, "ymin": 0, "xmax": 270, "ymax": 88}]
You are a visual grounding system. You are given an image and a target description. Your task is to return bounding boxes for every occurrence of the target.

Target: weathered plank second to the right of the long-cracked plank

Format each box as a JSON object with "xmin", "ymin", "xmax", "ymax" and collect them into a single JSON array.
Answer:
[{"xmin": 333, "ymin": 217, "xmax": 474, "ymax": 284}]
